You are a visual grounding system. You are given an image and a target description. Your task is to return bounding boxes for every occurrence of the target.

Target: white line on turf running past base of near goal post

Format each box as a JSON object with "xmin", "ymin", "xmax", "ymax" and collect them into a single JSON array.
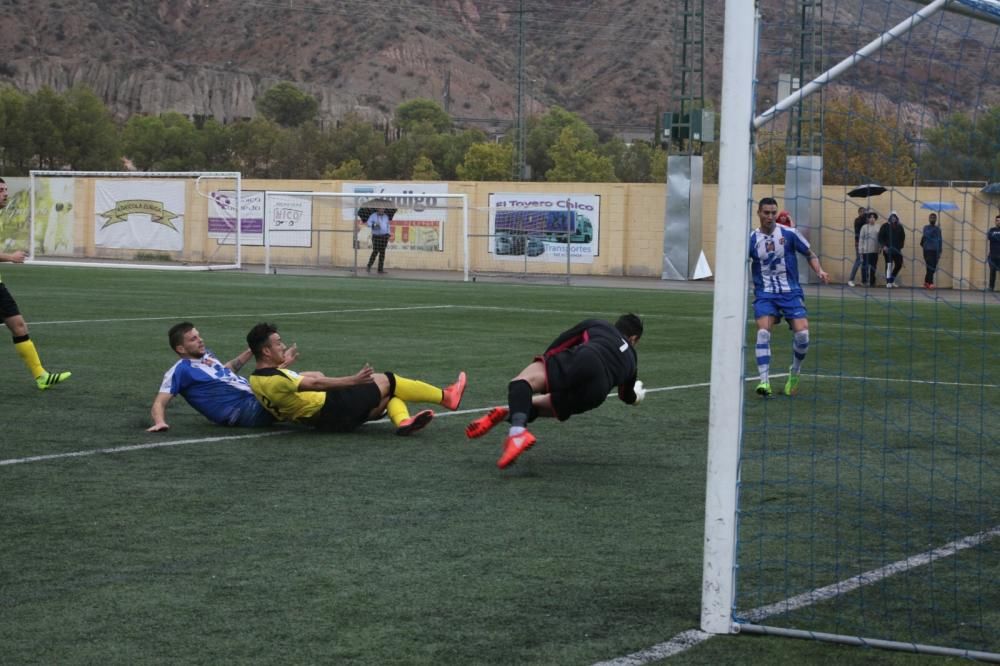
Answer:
[{"xmin": 594, "ymin": 525, "xmax": 1000, "ymax": 666}]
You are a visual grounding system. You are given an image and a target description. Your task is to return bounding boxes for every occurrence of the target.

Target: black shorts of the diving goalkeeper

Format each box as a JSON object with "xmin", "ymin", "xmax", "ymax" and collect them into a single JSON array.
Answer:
[{"xmin": 541, "ymin": 345, "xmax": 613, "ymax": 421}]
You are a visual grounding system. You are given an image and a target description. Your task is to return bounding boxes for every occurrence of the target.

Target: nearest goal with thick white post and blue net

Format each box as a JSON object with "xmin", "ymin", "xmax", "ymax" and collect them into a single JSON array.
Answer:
[{"xmin": 702, "ymin": 0, "xmax": 1000, "ymax": 661}]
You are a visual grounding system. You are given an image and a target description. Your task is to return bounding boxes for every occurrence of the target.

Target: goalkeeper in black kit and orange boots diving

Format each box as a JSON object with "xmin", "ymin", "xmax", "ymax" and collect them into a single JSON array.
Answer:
[{"xmin": 465, "ymin": 314, "xmax": 646, "ymax": 469}]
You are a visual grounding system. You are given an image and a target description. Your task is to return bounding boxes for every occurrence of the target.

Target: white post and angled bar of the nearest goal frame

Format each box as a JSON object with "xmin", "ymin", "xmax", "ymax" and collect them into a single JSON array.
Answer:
[{"xmin": 701, "ymin": 0, "xmax": 1000, "ymax": 656}]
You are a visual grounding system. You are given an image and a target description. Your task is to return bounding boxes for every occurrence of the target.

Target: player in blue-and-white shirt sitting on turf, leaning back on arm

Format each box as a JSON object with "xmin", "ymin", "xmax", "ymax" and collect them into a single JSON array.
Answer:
[{"xmin": 148, "ymin": 321, "xmax": 298, "ymax": 432}]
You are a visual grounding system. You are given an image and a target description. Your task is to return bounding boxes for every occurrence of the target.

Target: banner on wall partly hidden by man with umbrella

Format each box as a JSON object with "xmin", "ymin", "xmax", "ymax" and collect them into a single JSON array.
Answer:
[{"xmin": 341, "ymin": 183, "xmax": 448, "ymax": 252}]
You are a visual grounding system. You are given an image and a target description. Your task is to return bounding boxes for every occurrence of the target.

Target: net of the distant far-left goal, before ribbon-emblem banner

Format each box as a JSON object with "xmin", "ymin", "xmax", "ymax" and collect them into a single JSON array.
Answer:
[{"xmin": 24, "ymin": 171, "xmax": 243, "ymax": 270}]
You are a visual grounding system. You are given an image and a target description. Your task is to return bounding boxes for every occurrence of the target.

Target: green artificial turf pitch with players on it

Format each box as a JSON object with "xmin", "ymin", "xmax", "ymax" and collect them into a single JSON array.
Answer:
[{"xmin": 0, "ymin": 266, "xmax": 1000, "ymax": 664}]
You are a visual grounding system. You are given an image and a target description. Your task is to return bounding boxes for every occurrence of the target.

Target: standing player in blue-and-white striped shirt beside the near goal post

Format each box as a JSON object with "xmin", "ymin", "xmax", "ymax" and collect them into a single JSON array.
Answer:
[{"xmin": 750, "ymin": 197, "xmax": 830, "ymax": 398}]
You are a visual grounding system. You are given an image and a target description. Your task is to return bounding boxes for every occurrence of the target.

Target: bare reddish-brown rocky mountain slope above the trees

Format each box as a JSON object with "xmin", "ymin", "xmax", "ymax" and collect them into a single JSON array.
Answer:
[{"xmin": 0, "ymin": 0, "xmax": 996, "ymax": 131}]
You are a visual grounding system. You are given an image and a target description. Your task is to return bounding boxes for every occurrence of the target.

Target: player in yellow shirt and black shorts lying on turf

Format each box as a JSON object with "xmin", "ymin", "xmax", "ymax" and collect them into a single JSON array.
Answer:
[{"xmin": 247, "ymin": 323, "xmax": 466, "ymax": 435}]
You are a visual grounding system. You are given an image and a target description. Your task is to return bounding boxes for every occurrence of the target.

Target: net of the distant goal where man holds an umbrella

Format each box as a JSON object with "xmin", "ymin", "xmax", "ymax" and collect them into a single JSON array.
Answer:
[{"xmin": 260, "ymin": 188, "xmax": 469, "ymax": 279}]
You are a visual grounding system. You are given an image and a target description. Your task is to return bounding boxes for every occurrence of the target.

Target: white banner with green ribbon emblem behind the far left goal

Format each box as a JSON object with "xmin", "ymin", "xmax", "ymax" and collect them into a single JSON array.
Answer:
[{"xmin": 94, "ymin": 180, "xmax": 186, "ymax": 252}]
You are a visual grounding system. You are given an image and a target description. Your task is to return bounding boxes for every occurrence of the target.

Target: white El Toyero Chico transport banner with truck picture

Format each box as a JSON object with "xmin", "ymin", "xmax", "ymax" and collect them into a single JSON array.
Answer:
[{"xmin": 489, "ymin": 193, "xmax": 601, "ymax": 264}]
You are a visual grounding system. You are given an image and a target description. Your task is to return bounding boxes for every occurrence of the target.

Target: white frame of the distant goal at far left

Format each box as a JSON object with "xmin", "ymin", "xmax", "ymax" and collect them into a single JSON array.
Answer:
[{"xmin": 26, "ymin": 169, "xmax": 243, "ymax": 271}]
